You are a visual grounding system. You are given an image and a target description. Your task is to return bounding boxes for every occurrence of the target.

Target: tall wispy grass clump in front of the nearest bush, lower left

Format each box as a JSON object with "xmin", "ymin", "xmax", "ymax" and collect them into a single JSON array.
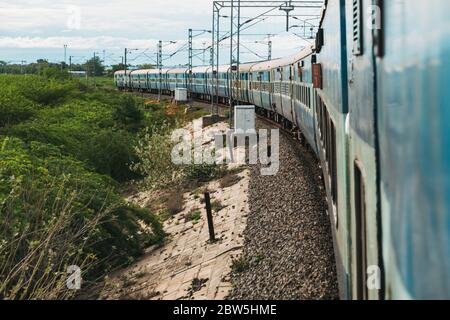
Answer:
[{"xmin": 0, "ymin": 180, "xmax": 104, "ymax": 300}]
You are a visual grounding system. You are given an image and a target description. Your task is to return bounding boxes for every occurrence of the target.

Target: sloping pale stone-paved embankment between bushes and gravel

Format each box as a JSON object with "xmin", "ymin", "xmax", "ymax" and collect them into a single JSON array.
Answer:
[{"xmin": 100, "ymin": 118, "xmax": 250, "ymax": 300}]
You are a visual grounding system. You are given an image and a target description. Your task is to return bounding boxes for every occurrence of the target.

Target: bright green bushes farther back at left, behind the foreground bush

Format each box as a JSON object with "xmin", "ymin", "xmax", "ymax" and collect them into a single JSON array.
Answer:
[{"xmin": 0, "ymin": 76, "xmax": 147, "ymax": 182}]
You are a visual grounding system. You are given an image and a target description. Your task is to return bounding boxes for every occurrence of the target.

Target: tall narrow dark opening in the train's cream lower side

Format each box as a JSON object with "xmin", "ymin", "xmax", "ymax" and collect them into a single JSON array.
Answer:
[{"xmin": 354, "ymin": 162, "xmax": 368, "ymax": 300}]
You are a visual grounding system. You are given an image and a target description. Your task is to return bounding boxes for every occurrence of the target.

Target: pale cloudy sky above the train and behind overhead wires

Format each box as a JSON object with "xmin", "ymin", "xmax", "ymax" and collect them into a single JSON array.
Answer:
[{"xmin": 0, "ymin": 0, "xmax": 320, "ymax": 65}]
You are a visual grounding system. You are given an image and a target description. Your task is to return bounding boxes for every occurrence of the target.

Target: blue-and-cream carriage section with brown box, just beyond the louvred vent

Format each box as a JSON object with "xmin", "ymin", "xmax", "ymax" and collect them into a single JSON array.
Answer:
[{"xmin": 312, "ymin": 0, "xmax": 354, "ymax": 299}]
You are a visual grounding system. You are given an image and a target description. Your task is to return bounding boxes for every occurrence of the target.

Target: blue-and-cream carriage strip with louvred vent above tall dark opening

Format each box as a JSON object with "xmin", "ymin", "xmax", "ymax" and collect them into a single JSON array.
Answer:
[{"xmin": 346, "ymin": 0, "xmax": 382, "ymax": 299}]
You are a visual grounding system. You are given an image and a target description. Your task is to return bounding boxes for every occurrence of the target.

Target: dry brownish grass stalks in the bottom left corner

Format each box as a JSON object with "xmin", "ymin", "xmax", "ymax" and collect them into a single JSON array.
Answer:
[{"xmin": 0, "ymin": 185, "xmax": 108, "ymax": 300}]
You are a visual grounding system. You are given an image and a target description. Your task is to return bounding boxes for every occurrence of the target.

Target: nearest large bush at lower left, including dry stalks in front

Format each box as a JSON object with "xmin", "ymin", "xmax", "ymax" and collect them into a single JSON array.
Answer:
[{"xmin": 0, "ymin": 138, "xmax": 165, "ymax": 299}]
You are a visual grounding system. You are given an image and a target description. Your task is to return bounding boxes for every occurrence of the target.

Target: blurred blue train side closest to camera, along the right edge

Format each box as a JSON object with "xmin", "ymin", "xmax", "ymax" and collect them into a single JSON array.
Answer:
[{"xmin": 376, "ymin": 0, "xmax": 450, "ymax": 299}]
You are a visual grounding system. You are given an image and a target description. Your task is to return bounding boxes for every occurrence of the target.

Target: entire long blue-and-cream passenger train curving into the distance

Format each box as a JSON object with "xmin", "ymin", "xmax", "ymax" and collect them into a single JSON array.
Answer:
[{"xmin": 114, "ymin": 0, "xmax": 450, "ymax": 300}]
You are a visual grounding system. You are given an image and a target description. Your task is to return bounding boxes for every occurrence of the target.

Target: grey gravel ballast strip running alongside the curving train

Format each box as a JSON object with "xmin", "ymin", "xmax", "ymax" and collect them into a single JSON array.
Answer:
[{"xmin": 229, "ymin": 120, "xmax": 339, "ymax": 300}]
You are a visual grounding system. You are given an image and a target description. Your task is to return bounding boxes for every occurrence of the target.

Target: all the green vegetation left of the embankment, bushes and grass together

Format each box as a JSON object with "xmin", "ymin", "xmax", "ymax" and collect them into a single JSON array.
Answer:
[{"xmin": 0, "ymin": 74, "xmax": 176, "ymax": 299}]
